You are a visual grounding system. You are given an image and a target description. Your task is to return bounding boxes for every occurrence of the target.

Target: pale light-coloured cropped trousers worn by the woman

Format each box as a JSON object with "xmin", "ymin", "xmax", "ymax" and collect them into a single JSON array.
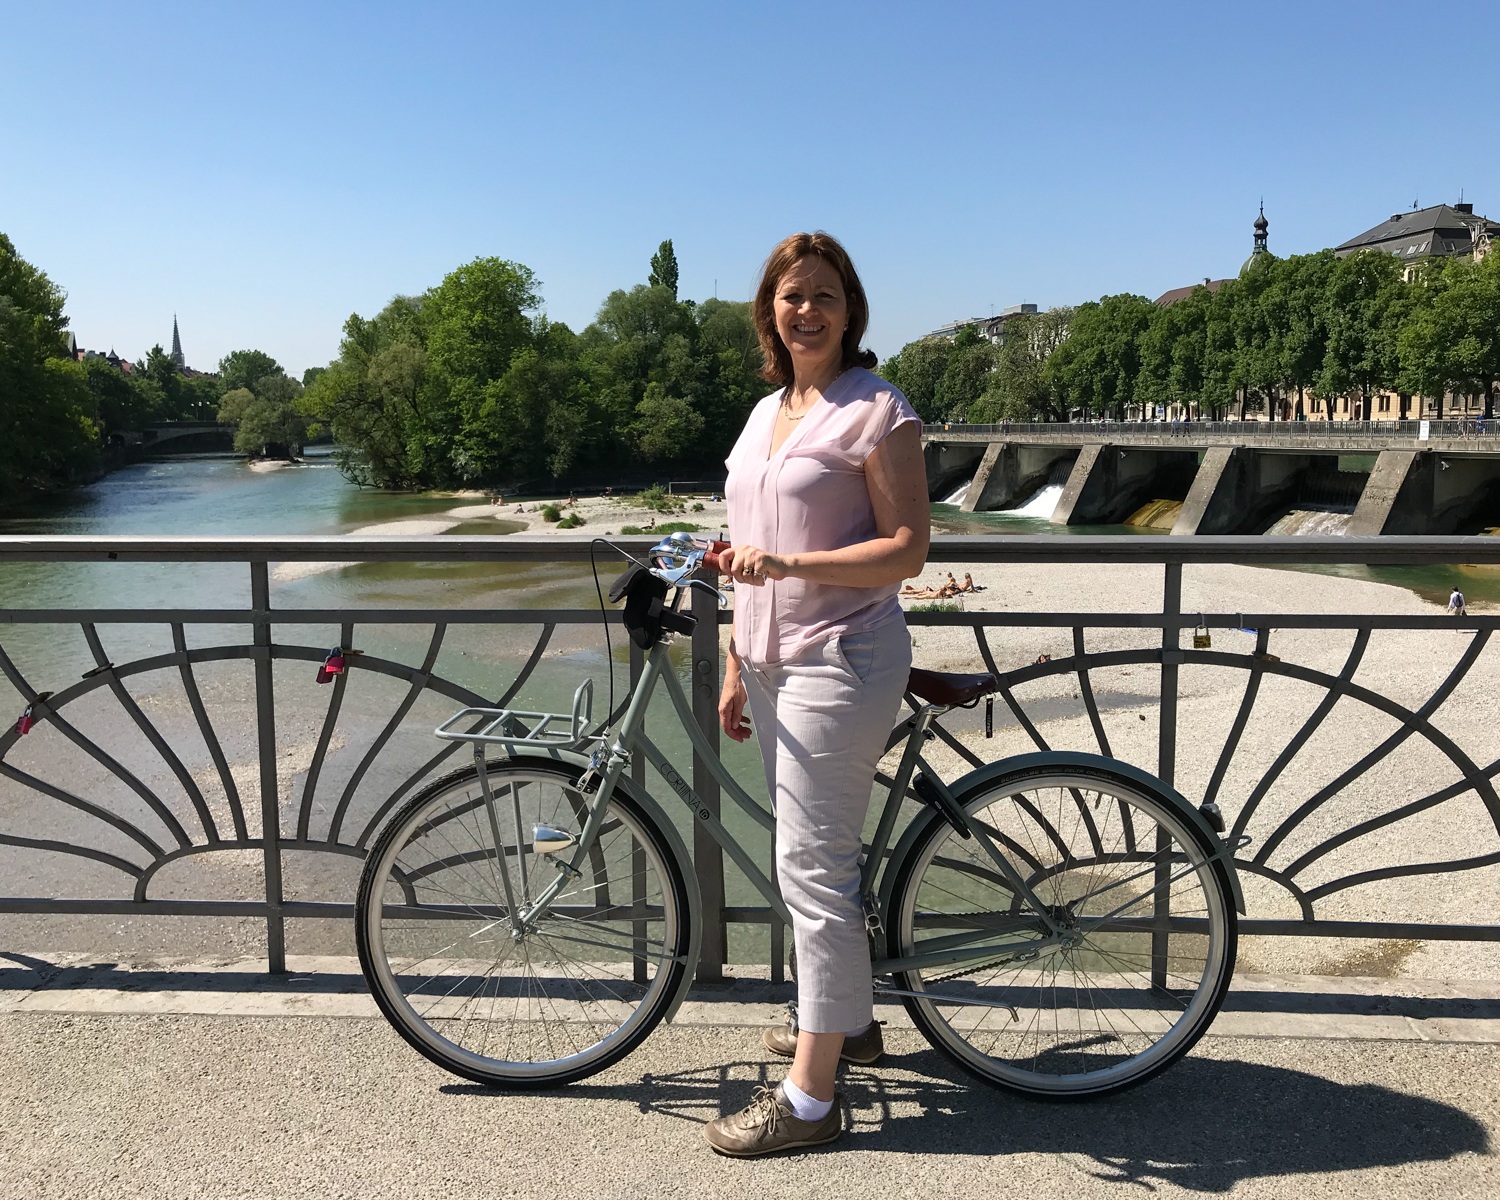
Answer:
[{"xmin": 743, "ymin": 621, "xmax": 912, "ymax": 1034}]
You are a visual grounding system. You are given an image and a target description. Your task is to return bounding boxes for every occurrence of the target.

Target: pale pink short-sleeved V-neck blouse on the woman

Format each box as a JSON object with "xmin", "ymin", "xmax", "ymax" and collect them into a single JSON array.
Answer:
[{"xmin": 725, "ymin": 368, "xmax": 920, "ymax": 663}]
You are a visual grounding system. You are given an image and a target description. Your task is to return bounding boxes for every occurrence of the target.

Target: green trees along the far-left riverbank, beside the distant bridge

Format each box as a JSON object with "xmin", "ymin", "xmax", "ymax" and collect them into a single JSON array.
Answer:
[{"xmin": 0, "ymin": 234, "xmax": 309, "ymax": 500}]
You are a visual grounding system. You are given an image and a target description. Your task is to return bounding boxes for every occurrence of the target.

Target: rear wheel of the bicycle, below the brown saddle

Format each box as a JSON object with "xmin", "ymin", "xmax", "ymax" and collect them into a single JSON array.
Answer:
[{"xmin": 888, "ymin": 765, "xmax": 1238, "ymax": 1100}]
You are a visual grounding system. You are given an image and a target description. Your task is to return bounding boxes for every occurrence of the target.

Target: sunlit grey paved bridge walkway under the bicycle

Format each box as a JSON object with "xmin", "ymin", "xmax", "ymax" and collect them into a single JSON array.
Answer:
[{"xmin": 0, "ymin": 956, "xmax": 1500, "ymax": 1200}]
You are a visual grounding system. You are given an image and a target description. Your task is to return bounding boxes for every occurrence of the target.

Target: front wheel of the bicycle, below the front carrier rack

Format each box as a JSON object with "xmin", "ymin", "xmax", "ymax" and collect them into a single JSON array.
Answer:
[{"xmin": 356, "ymin": 762, "xmax": 689, "ymax": 1088}]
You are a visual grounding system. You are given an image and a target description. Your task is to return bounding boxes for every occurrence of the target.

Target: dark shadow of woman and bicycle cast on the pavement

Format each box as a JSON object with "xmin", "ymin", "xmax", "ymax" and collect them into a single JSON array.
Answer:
[{"xmin": 441, "ymin": 1050, "xmax": 1490, "ymax": 1193}]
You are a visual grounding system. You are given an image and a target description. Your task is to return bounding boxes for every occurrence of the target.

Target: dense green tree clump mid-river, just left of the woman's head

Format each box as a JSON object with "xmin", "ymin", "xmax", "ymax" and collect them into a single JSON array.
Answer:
[{"xmin": 300, "ymin": 242, "xmax": 767, "ymax": 488}]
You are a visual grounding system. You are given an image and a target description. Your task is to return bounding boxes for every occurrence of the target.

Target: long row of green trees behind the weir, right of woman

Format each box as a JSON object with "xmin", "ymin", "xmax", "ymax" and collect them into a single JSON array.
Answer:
[{"xmin": 882, "ymin": 251, "xmax": 1500, "ymax": 422}]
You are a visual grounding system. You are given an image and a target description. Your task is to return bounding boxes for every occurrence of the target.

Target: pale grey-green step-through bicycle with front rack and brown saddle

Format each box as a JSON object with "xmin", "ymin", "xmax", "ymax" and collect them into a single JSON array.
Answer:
[{"xmin": 356, "ymin": 534, "xmax": 1244, "ymax": 1100}]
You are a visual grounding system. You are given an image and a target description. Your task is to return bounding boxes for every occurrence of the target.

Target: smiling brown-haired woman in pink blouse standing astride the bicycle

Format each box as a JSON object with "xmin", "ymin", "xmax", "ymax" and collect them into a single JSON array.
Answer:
[{"xmin": 705, "ymin": 233, "xmax": 929, "ymax": 1157}]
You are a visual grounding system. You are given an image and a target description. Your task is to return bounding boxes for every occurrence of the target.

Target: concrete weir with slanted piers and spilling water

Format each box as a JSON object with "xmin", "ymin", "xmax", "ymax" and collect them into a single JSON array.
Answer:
[{"xmin": 923, "ymin": 422, "xmax": 1500, "ymax": 534}]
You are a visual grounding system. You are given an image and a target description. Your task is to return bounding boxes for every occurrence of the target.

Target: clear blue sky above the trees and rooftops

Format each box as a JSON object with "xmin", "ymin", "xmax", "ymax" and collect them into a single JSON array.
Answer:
[{"xmin": 0, "ymin": 0, "xmax": 1500, "ymax": 372}]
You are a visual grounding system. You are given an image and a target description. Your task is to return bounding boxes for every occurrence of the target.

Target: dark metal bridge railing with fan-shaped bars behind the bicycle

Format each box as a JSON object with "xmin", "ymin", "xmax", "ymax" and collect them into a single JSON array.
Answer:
[{"xmin": 0, "ymin": 537, "xmax": 1500, "ymax": 978}]
